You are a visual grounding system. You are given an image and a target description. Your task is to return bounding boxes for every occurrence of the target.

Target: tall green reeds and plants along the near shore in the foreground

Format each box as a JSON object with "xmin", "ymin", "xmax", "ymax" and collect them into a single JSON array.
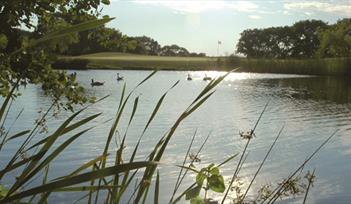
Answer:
[{"xmin": 0, "ymin": 72, "xmax": 335, "ymax": 203}]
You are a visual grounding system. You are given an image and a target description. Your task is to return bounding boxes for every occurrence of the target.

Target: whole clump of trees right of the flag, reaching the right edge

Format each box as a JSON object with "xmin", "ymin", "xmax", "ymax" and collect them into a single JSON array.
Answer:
[{"xmin": 236, "ymin": 18, "xmax": 351, "ymax": 59}]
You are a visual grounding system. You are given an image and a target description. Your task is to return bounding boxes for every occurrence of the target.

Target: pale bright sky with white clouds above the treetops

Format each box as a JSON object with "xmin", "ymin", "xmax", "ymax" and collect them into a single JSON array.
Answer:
[{"xmin": 102, "ymin": 0, "xmax": 351, "ymax": 56}]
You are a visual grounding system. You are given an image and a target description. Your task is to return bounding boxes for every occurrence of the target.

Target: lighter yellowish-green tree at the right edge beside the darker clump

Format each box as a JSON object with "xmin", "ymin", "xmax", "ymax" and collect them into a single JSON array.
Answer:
[{"xmin": 316, "ymin": 18, "xmax": 351, "ymax": 57}]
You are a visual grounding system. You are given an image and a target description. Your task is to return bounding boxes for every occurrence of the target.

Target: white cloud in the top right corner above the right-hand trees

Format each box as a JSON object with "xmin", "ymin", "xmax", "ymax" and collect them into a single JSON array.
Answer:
[{"xmin": 284, "ymin": 1, "xmax": 351, "ymax": 17}]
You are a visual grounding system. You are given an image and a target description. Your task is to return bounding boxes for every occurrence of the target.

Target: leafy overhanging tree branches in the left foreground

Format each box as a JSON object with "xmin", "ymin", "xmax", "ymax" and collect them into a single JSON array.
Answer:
[{"xmin": 0, "ymin": 0, "xmax": 109, "ymax": 109}]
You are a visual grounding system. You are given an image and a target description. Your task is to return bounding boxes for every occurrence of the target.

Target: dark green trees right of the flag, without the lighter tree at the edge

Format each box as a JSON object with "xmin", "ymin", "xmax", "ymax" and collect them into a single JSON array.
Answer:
[{"xmin": 237, "ymin": 20, "xmax": 327, "ymax": 58}]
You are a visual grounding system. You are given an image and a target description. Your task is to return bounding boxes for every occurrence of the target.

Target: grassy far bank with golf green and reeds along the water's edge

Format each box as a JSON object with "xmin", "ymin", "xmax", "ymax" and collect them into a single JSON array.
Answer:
[{"xmin": 55, "ymin": 53, "xmax": 351, "ymax": 76}]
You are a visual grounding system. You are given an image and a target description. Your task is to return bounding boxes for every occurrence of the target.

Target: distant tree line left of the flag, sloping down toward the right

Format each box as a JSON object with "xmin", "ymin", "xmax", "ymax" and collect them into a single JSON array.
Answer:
[{"xmin": 56, "ymin": 26, "xmax": 206, "ymax": 57}]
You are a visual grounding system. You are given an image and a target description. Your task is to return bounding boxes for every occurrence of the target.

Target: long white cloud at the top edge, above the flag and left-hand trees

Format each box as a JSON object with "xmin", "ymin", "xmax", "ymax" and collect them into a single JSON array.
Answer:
[{"xmin": 133, "ymin": 0, "xmax": 258, "ymax": 13}]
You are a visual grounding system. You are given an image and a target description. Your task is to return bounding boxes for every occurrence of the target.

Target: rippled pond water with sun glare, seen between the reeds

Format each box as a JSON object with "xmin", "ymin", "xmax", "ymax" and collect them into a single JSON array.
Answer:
[{"xmin": 0, "ymin": 70, "xmax": 351, "ymax": 203}]
